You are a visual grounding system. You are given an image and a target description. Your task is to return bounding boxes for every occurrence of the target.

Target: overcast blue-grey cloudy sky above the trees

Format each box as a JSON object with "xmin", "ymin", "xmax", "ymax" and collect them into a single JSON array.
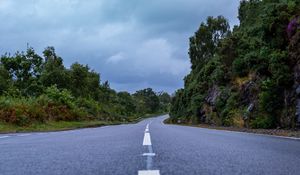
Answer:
[{"xmin": 0, "ymin": 0, "xmax": 239, "ymax": 93}]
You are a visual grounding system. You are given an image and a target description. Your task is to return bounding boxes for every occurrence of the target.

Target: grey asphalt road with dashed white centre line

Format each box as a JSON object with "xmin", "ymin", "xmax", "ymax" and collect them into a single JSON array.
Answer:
[{"xmin": 0, "ymin": 116, "xmax": 300, "ymax": 175}]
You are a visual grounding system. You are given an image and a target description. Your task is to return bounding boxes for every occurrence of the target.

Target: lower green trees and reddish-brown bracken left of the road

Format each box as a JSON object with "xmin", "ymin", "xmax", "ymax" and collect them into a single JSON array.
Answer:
[{"xmin": 0, "ymin": 47, "xmax": 171, "ymax": 126}]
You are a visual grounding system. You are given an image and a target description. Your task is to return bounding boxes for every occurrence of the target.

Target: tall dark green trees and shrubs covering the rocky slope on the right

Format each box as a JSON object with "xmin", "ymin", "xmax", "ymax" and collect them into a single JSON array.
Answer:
[{"xmin": 171, "ymin": 0, "xmax": 300, "ymax": 128}]
